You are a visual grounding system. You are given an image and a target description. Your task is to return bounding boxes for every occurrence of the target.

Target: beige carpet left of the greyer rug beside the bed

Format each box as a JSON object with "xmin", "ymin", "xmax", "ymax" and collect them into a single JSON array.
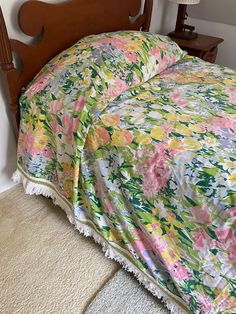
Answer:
[{"xmin": 0, "ymin": 185, "xmax": 119, "ymax": 314}]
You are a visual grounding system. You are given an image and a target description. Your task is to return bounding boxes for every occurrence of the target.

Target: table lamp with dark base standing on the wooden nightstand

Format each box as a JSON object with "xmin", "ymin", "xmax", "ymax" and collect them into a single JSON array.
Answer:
[{"xmin": 169, "ymin": 0, "xmax": 200, "ymax": 40}]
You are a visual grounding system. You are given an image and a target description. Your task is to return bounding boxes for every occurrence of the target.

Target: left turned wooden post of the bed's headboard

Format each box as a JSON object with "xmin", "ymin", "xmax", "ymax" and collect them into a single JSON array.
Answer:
[{"xmin": 0, "ymin": 6, "xmax": 20, "ymax": 139}]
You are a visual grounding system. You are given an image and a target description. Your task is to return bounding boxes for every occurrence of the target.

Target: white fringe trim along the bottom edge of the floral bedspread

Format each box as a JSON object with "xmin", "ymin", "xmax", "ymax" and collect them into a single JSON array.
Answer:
[{"xmin": 12, "ymin": 170, "xmax": 191, "ymax": 314}]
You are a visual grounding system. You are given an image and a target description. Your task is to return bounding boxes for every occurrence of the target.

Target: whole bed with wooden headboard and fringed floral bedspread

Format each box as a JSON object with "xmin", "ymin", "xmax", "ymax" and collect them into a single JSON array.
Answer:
[{"xmin": 0, "ymin": 0, "xmax": 236, "ymax": 314}]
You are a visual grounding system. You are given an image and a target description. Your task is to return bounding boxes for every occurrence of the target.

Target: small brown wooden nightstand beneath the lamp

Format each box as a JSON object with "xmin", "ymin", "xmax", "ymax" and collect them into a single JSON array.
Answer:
[{"xmin": 169, "ymin": 34, "xmax": 224, "ymax": 63}]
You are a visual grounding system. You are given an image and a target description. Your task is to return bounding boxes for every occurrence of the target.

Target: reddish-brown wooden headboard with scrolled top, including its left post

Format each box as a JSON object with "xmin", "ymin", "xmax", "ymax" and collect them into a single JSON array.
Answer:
[{"xmin": 0, "ymin": 0, "xmax": 153, "ymax": 135}]
